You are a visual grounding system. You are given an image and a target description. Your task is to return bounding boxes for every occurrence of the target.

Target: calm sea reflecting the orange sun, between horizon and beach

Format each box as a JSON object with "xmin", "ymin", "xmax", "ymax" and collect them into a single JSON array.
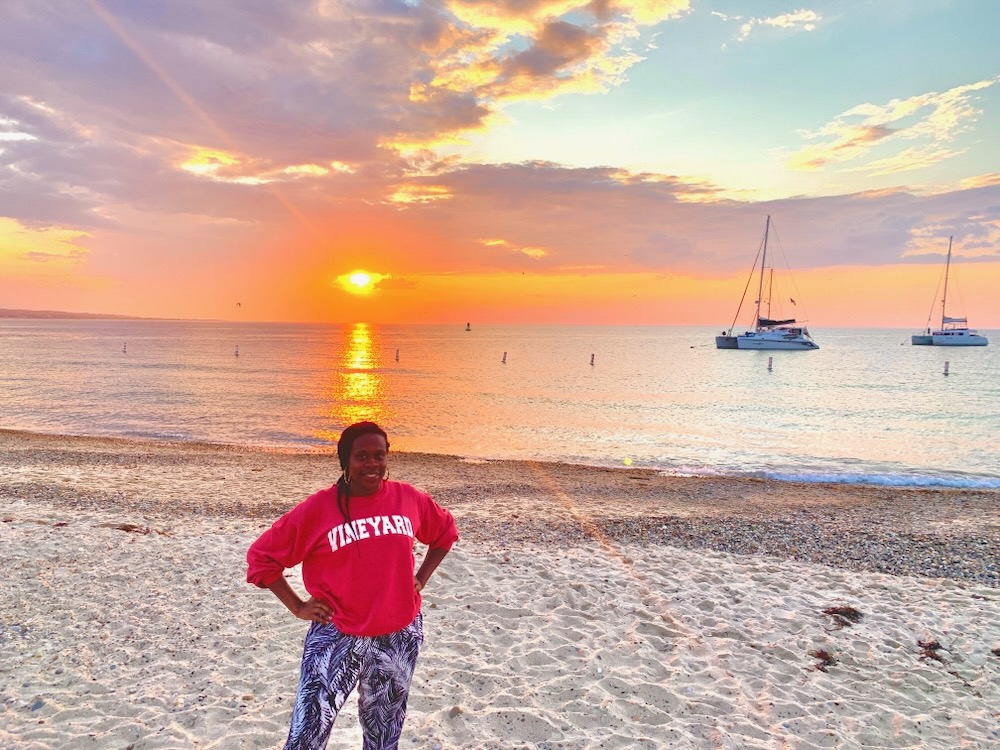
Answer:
[{"xmin": 0, "ymin": 319, "xmax": 1000, "ymax": 488}]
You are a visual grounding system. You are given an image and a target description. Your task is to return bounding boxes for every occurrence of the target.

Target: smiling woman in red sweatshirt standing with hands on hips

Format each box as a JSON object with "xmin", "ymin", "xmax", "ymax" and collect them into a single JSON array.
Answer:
[{"xmin": 247, "ymin": 422, "xmax": 458, "ymax": 750}]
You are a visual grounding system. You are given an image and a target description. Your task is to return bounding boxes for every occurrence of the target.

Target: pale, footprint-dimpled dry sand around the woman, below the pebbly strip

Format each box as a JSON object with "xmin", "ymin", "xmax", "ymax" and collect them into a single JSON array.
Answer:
[{"xmin": 0, "ymin": 435, "xmax": 1000, "ymax": 750}]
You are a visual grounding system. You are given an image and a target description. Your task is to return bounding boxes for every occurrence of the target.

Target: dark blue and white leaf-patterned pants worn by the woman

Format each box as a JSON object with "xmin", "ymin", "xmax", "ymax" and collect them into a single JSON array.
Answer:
[{"xmin": 285, "ymin": 614, "xmax": 424, "ymax": 750}]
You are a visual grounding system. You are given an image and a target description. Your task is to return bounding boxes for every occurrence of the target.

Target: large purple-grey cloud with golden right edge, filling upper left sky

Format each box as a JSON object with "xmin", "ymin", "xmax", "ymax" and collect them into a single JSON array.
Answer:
[{"xmin": 0, "ymin": 0, "xmax": 686, "ymax": 212}]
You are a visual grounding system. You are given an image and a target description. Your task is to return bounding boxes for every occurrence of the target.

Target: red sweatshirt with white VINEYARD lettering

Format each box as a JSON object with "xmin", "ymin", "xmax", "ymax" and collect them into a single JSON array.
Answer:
[{"xmin": 247, "ymin": 481, "xmax": 458, "ymax": 636}]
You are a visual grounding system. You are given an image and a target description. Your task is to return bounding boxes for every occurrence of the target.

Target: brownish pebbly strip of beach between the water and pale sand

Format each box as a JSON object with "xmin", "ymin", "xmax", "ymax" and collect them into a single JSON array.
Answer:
[{"xmin": 0, "ymin": 431, "xmax": 1000, "ymax": 588}]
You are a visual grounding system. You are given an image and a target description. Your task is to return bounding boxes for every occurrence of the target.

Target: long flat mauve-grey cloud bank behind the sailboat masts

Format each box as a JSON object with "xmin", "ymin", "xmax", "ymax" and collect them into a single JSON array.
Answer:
[{"xmin": 354, "ymin": 163, "xmax": 1000, "ymax": 276}]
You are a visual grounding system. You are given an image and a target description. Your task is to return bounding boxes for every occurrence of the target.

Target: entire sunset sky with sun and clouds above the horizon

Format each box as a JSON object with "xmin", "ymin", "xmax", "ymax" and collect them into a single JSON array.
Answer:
[{"xmin": 0, "ymin": 0, "xmax": 1000, "ymax": 333}]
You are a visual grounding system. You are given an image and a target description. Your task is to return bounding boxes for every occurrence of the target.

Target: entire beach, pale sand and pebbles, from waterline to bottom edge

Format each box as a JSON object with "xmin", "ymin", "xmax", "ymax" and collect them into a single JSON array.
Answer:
[{"xmin": 0, "ymin": 431, "xmax": 1000, "ymax": 750}]
